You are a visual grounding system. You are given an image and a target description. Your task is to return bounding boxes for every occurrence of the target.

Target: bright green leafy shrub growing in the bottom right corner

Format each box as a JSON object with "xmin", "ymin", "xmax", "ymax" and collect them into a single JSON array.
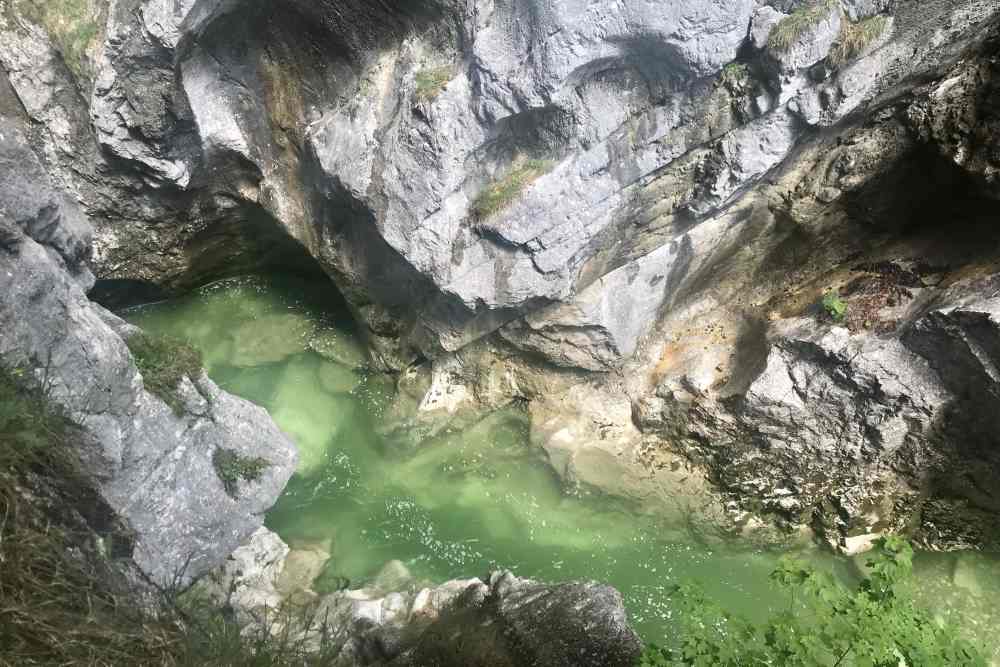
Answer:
[{"xmin": 639, "ymin": 537, "xmax": 987, "ymax": 667}]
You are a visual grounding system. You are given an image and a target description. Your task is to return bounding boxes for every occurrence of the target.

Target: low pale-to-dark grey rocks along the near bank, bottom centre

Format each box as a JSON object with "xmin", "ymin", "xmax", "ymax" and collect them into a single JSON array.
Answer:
[{"xmin": 201, "ymin": 529, "xmax": 642, "ymax": 667}]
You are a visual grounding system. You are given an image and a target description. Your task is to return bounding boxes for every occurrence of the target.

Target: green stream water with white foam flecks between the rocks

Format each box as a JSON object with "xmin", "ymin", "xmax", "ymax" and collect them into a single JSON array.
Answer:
[{"xmin": 126, "ymin": 276, "xmax": 1000, "ymax": 656}]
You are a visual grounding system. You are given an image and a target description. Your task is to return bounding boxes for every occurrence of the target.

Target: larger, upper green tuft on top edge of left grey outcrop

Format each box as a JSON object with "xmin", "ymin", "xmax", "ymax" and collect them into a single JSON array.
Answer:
[{"xmin": 125, "ymin": 333, "xmax": 202, "ymax": 415}]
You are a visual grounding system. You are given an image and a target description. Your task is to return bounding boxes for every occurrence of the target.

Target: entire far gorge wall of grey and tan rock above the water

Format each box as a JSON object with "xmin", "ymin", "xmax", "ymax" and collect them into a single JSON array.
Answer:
[{"xmin": 0, "ymin": 0, "xmax": 1000, "ymax": 550}]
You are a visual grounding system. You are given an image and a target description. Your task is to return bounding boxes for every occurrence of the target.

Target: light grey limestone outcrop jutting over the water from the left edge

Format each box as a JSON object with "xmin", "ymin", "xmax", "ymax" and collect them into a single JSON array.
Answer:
[{"xmin": 0, "ymin": 118, "xmax": 297, "ymax": 585}]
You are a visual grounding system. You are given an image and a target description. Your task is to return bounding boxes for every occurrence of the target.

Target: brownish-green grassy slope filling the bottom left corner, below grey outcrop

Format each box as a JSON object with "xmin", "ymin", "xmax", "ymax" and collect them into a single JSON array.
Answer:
[{"xmin": 0, "ymin": 367, "xmax": 338, "ymax": 667}]
